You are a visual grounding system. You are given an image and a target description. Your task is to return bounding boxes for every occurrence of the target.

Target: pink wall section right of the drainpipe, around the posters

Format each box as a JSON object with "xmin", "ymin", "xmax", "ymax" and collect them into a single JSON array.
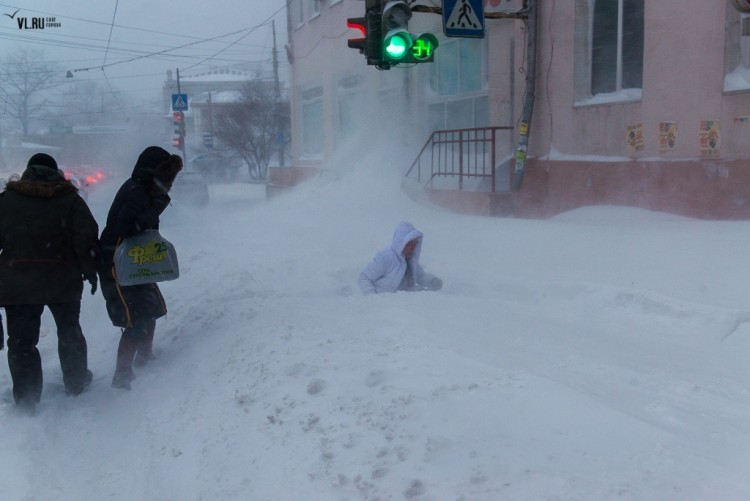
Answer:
[{"xmin": 496, "ymin": 0, "xmax": 750, "ymax": 219}]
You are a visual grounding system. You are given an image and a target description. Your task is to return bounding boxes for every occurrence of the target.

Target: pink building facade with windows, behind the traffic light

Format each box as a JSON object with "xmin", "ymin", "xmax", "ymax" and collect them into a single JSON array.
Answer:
[{"xmin": 288, "ymin": 0, "xmax": 750, "ymax": 219}]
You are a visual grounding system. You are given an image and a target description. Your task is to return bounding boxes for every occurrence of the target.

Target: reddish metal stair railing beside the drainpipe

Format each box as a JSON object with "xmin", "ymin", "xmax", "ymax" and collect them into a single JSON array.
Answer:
[{"xmin": 405, "ymin": 126, "xmax": 513, "ymax": 192}]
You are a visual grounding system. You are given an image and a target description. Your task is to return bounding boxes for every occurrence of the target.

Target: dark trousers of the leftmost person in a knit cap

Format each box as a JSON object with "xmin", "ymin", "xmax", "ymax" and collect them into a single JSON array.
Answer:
[{"xmin": 5, "ymin": 301, "xmax": 88, "ymax": 403}]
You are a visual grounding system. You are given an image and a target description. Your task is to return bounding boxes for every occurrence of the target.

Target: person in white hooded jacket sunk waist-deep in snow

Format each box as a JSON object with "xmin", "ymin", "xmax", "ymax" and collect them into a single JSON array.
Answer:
[{"xmin": 359, "ymin": 221, "xmax": 443, "ymax": 294}]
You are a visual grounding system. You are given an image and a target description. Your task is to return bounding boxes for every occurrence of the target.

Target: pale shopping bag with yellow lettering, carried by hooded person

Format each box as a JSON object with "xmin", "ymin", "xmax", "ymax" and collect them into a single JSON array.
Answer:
[{"xmin": 115, "ymin": 230, "xmax": 180, "ymax": 285}]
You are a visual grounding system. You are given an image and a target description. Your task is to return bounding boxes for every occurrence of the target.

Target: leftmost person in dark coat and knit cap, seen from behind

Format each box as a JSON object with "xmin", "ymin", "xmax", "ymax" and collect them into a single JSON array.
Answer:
[{"xmin": 0, "ymin": 153, "xmax": 99, "ymax": 412}]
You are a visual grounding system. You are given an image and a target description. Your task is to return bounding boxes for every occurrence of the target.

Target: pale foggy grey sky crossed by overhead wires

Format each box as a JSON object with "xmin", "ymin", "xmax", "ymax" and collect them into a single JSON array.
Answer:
[{"xmin": 0, "ymin": 0, "xmax": 287, "ymax": 99}]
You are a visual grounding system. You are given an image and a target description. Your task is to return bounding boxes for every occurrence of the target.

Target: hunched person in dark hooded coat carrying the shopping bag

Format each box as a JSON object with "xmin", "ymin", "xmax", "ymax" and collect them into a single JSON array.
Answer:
[{"xmin": 99, "ymin": 146, "xmax": 182, "ymax": 390}]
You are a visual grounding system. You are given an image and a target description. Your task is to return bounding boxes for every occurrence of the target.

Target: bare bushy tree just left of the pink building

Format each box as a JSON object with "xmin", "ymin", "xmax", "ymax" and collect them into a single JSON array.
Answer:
[{"xmin": 214, "ymin": 79, "xmax": 288, "ymax": 181}]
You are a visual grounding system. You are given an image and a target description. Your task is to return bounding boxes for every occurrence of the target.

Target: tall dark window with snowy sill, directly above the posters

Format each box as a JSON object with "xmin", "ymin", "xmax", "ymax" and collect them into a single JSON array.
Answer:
[{"xmin": 591, "ymin": 0, "xmax": 644, "ymax": 96}]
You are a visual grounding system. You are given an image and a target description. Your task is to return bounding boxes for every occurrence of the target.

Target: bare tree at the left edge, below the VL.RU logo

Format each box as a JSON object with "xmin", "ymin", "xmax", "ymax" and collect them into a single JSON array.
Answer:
[{"xmin": 0, "ymin": 47, "xmax": 62, "ymax": 136}]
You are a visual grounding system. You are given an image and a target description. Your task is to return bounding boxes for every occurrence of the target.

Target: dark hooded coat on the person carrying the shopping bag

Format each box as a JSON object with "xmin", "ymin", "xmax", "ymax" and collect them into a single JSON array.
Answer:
[{"xmin": 99, "ymin": 146, "xmax": 182, "ymax": 327}]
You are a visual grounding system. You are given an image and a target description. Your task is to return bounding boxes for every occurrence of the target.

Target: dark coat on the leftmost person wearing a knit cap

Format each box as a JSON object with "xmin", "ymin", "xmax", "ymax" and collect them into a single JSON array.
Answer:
[{"xmin": 0, "ymin": 165, "xmax": 99, "ymax": 306}]
